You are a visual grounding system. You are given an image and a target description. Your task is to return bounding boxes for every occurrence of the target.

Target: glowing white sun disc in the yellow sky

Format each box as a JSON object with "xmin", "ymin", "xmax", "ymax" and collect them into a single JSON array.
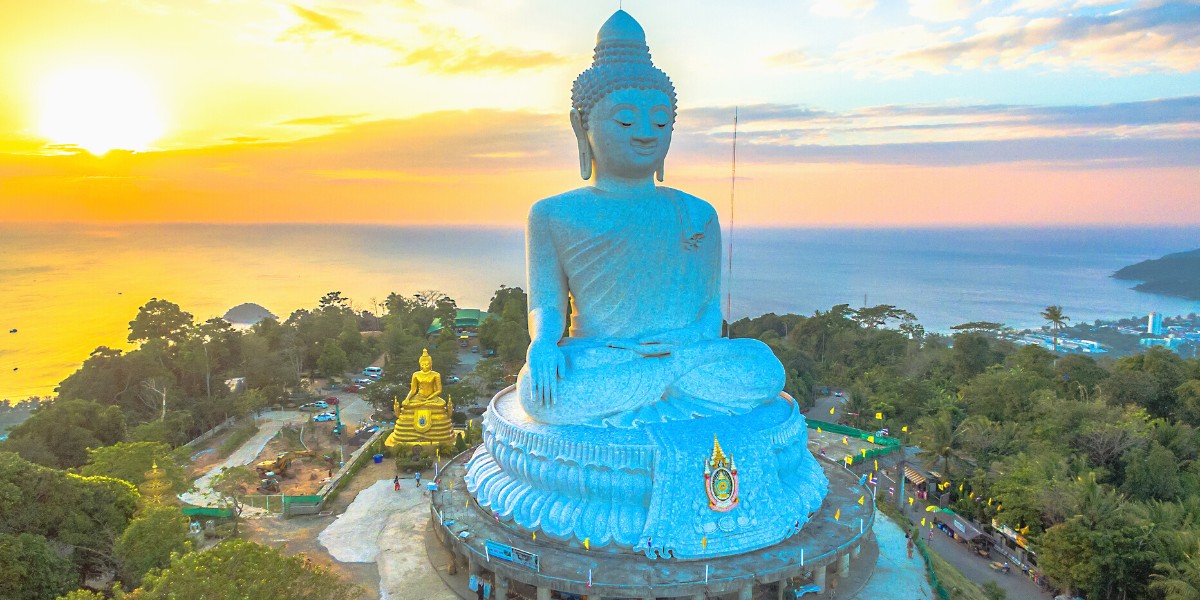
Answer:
[{"xmin": 37, "ymin": 67, "xmax": 164, "ymax": 156}]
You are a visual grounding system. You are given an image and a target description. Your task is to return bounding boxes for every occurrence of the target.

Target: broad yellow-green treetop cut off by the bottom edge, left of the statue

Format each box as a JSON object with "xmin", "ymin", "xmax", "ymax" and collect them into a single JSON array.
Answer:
[{"xmin": 130, "ymin": 540, "xmax": 361, "ymax": 600}]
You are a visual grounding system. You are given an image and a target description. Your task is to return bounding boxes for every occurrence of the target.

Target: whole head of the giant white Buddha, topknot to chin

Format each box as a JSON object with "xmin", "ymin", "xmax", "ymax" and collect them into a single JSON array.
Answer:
[{"xmin": 571, "ymin": 11, "xmax": 676, "ymax": 181}]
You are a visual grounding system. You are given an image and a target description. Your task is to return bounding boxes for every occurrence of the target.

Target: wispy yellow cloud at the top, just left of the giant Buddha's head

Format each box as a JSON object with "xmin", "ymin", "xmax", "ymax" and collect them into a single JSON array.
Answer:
[{"xmin": 282, "ymin": 5, "xmax": 568, "ymax": 74}]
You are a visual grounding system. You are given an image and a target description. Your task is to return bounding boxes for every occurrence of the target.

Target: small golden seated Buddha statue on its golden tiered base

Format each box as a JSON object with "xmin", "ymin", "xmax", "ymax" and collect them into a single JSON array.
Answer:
[{"xmin": 384, "ymin": 349, "xmax": 454, "ymax": 448}]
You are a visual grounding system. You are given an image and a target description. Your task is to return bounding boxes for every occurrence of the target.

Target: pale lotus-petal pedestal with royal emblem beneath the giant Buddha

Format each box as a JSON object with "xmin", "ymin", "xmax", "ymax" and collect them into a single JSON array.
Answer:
[{"xmin": 464, "ymin": 388, "xmax": 827, "ymax": 559}]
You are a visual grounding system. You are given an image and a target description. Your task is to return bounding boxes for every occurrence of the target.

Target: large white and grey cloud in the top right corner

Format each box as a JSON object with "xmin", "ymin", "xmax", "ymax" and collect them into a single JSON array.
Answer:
[{"xmin": 768, "ymin": 2, "xmax": 1200, "ymax": 77}]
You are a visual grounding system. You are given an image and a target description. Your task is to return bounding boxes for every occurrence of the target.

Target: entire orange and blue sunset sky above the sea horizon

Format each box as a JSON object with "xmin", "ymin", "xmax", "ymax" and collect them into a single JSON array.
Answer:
[{"xmin": 0, "ymin": 0, "xmax": 1200, "ymax": 227}]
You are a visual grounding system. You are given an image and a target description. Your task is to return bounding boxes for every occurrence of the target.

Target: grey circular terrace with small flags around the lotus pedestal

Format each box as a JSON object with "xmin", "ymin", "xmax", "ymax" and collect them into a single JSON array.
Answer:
[{"xmin": 431, "ymin": 450, "xmax": 875, "ymax": 600}]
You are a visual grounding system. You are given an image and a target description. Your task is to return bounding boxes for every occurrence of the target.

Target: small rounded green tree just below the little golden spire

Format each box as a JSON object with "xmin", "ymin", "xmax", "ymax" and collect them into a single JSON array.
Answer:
[{"xmin": 113, "ymin": 506, "xmax": 192, "ymax": 588}]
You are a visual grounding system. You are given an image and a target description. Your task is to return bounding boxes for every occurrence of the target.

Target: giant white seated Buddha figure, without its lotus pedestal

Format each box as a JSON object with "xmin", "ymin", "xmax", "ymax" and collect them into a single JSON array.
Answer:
[{"xmin": 517, "ymin": 11, "xmax": 785, "ymax": 426}]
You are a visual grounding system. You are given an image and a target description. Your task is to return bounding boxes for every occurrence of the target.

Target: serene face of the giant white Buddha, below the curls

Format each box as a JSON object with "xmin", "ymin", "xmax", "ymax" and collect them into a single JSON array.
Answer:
[{"xmin": 587, "ymin": 88, "xmax": 673, "ymax": 179}]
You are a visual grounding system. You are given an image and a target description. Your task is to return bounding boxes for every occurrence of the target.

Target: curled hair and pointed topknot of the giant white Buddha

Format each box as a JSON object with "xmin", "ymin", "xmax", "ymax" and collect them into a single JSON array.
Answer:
[{"xmin": 571, "ymin": 11, "xmax": 676, "ymax": 128}]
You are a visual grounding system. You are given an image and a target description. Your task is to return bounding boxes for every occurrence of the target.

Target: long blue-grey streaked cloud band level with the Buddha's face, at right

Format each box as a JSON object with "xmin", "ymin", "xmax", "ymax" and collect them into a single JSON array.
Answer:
[{"xmin": 678, "ymin": 96, "xmax": 1200, "ymax": 168}]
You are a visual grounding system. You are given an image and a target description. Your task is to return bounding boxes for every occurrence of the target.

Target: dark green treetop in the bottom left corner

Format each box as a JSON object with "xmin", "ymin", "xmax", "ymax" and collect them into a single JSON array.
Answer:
[{"xmin": 0, "ymin": 533, "xmax": 77, "ymax": 600}]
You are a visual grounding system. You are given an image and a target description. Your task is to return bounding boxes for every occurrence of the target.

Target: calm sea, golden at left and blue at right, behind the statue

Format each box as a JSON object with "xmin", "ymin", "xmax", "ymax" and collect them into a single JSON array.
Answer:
[{"xmin": 0, "ymin": 224, "xmax": 1200, "ymax": 400}]
